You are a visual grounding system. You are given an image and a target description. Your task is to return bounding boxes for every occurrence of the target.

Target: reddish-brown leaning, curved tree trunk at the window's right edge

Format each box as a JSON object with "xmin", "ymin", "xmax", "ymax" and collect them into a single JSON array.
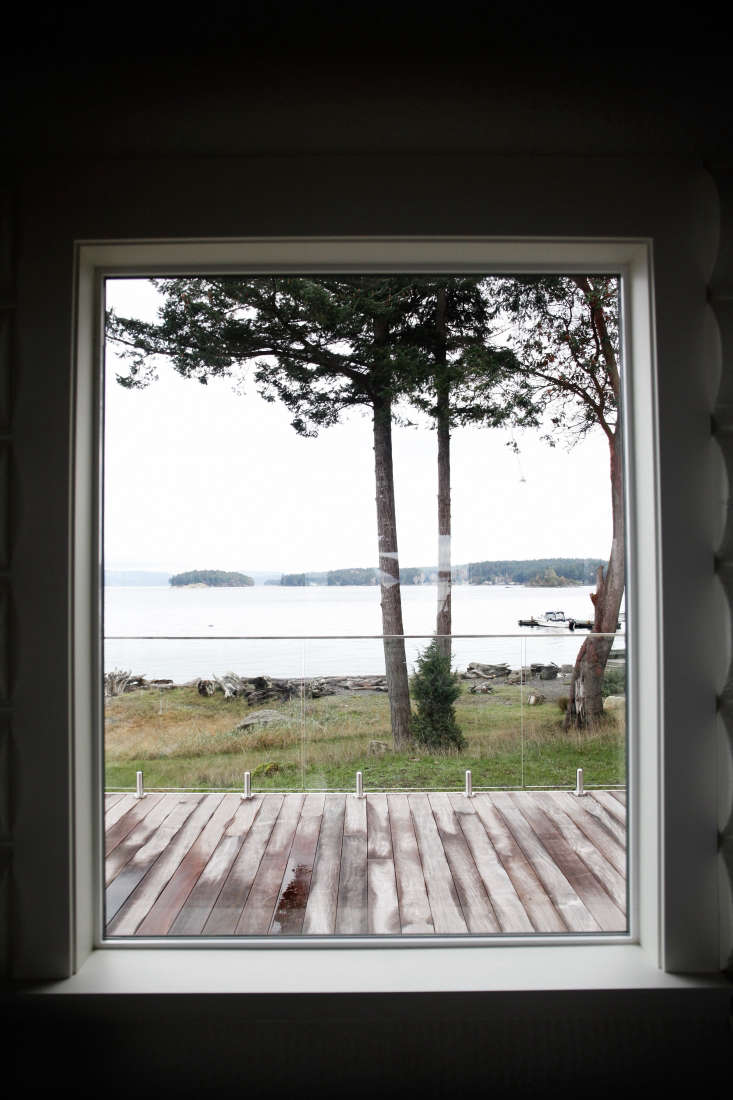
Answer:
[{"xmin": 565, "ymin": 427, "xmax": 624, "ymax": 729}]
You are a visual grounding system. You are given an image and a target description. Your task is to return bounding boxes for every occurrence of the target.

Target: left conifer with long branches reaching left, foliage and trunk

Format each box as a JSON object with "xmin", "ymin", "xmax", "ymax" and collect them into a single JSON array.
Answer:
[{"xmin": 107, "ymin": 275, "xmax": 427, "ymax": 748}]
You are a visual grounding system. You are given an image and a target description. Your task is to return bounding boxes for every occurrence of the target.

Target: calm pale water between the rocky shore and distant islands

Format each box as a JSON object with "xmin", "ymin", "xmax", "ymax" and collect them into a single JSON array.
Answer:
[{"xmin": 105, "ymin": 584, "xmax": 620, "ymax": 683}]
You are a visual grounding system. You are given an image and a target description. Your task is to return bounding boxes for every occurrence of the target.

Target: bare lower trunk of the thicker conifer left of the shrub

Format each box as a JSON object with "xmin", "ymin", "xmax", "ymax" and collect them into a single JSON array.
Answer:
[{"xmin": 373, "ymin": 398, "xmax": 412, "ymax": 749}]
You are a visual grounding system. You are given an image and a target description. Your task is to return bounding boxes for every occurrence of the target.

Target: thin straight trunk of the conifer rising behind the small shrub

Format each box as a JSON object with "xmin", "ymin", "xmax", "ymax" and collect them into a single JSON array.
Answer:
[{"xmin": 435, "ymin": 287, "xmax": 452, "ymax": 657}]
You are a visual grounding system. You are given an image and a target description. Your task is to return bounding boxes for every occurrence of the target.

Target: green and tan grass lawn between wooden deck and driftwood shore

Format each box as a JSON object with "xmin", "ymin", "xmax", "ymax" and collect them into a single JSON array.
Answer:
[{"xmin": 105, "ymin": 685, "xmax": 625, "ymax": 790}]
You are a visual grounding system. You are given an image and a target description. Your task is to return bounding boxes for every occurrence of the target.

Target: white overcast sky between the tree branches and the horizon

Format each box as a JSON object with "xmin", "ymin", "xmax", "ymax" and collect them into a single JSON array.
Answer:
[{"xmin": 105, "ymin": 279, "xmax": 611, "ymax": 572}]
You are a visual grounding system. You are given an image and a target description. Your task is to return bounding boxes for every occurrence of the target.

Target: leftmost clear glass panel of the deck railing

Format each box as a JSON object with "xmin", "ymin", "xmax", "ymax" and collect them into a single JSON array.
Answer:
[{"xmin": 103, "ymin": 638, "xmax": 304, "ymax": 791}]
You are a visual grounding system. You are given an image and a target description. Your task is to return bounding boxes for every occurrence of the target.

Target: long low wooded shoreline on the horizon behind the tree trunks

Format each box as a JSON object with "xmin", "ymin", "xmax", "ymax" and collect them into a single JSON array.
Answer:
[{"xmin": 274, "ymin": 558, "xmax": 606, "ymax": 589}]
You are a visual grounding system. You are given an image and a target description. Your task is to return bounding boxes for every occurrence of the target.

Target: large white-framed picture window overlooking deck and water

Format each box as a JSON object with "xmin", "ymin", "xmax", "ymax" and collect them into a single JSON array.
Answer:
[{"xmin": 81, "ymin": 242, "xmax": 654, "ymax": 946}]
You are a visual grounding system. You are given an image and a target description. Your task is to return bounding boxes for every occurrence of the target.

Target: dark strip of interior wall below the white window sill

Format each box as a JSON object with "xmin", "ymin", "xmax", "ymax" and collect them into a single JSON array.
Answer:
[{"xmin": 8, "ymin": 990, "xmax": 733, "ymax": 1100}]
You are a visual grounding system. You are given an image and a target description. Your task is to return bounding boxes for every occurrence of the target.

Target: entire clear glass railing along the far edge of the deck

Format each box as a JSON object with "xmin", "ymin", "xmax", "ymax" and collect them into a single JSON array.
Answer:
[{"xmin": 105, "ymin": 630, "xmax": 626, "ymax": 791}]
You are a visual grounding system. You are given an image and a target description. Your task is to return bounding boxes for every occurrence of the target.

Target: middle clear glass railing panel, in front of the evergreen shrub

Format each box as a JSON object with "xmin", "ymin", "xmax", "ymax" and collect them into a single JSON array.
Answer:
[{"xmin": 294, "ymin": 636, "xmax": 523, "ymax": 791}]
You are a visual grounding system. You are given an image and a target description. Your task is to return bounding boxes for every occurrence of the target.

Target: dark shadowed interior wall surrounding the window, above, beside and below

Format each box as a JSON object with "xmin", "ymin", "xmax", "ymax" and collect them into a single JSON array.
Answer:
[{"xmin": 0, "ymin": 24, "xmax": 733, "ymax": 1095}]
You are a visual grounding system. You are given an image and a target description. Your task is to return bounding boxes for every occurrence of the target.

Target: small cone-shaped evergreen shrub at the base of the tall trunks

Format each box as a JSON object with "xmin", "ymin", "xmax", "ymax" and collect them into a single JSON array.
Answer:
[{"xmin": 412, "ymin": 638, "xmax": 466, "ymax": 750}]
